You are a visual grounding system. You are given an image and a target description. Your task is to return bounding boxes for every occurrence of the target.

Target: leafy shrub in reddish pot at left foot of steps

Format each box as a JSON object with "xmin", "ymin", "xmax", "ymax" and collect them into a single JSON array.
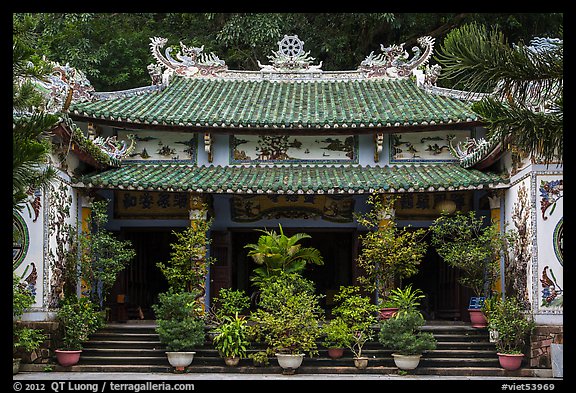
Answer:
[{"xmin": 55, "ymin": 295, "xmax": 104, "ymax": 367}]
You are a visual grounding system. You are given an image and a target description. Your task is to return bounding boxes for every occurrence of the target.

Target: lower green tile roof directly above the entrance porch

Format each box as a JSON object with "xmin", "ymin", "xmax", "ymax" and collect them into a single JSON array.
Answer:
[{"xmin": 76, "ymin": 163, "xmax": 508, "ymax": 194}]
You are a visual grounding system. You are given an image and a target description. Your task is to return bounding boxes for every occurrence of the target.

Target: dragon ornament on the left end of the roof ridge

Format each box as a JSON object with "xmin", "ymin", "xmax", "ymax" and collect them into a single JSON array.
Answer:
[{"xmin": 149, "ymin": 37, "xmax": 228, "ymax": 78}]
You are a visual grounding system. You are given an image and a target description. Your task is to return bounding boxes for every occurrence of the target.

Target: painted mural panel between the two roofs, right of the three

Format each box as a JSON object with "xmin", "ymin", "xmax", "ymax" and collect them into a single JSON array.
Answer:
[{"xmin": 390, "ymin": 130, "xmax": 472, "ymax": 164}]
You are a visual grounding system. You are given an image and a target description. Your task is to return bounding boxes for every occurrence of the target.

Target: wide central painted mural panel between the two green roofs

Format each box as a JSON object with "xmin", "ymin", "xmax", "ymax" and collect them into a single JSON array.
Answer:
[{"xmin": 230, "ymin": 135, "xmax": 358, "ymax": 164}]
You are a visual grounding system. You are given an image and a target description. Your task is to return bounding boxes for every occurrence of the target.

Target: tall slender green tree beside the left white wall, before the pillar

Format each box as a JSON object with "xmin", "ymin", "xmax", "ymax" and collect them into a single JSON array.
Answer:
[{"xmin": 78, "ymin": 200, "xmax": 136, "ymax": 310}]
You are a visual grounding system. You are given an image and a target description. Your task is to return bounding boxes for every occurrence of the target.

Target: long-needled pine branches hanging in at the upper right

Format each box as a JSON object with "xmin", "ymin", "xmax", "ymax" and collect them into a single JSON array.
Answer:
[{"xmin": 437, "ymin": 24, "xmax": 564, "ymax": 162}]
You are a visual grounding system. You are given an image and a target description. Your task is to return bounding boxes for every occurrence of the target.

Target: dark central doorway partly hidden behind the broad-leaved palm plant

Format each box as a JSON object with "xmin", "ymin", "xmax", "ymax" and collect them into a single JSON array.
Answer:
[{"xmin": 217, "ymin": 228, "xmax": 354, "ymax": 309}]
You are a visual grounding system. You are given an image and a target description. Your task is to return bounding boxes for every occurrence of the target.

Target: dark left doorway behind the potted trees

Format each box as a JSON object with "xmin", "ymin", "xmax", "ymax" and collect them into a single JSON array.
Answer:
[{"xmin": 109, "ymin": 228, "xmax": 176, "ymax": 320}]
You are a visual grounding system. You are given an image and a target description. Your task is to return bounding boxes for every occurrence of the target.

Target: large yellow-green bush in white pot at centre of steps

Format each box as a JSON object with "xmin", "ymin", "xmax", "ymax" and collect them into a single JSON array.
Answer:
[{"xmin": 250, "ymin": 271, "xmax": 322, "ymax": 375}]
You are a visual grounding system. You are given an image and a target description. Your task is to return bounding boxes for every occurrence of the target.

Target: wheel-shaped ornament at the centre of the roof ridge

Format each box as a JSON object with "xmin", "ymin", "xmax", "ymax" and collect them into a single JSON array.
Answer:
[{"xmin": 258, "ymin": 35, "xmax": 322, "ymax": 73}]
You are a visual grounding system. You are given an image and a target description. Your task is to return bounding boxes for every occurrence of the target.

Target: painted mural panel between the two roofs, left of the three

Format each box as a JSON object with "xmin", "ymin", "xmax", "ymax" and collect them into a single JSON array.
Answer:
[{"xmin": 115, "ymin": 129, "xmax": 198, "ymax": 163}]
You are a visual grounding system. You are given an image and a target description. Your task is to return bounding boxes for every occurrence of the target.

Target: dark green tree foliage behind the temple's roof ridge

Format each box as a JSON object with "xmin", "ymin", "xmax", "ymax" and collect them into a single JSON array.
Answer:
[{"xmin": 13, "ymin": 13, "xmax": 563, "ymax": 91}]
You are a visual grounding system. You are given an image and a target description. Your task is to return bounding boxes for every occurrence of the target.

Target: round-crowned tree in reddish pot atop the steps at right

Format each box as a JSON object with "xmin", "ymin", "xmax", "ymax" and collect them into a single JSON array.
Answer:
[{"xmin": 430, "ymin": 211, "xmax": 507, "ymax": 328}]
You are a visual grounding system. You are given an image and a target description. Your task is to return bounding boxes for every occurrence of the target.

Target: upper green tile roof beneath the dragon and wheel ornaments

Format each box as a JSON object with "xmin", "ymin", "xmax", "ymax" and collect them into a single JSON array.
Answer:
[{"xmin": 69, "ymin": 77, "xmax": 480, "ymax": 129}]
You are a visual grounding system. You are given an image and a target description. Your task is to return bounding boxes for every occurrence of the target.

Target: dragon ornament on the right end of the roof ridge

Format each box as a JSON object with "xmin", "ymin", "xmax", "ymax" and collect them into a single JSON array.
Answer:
[{"xmin": 358, "ymin": 36, "xmax": 435, "ymax": 79}]
